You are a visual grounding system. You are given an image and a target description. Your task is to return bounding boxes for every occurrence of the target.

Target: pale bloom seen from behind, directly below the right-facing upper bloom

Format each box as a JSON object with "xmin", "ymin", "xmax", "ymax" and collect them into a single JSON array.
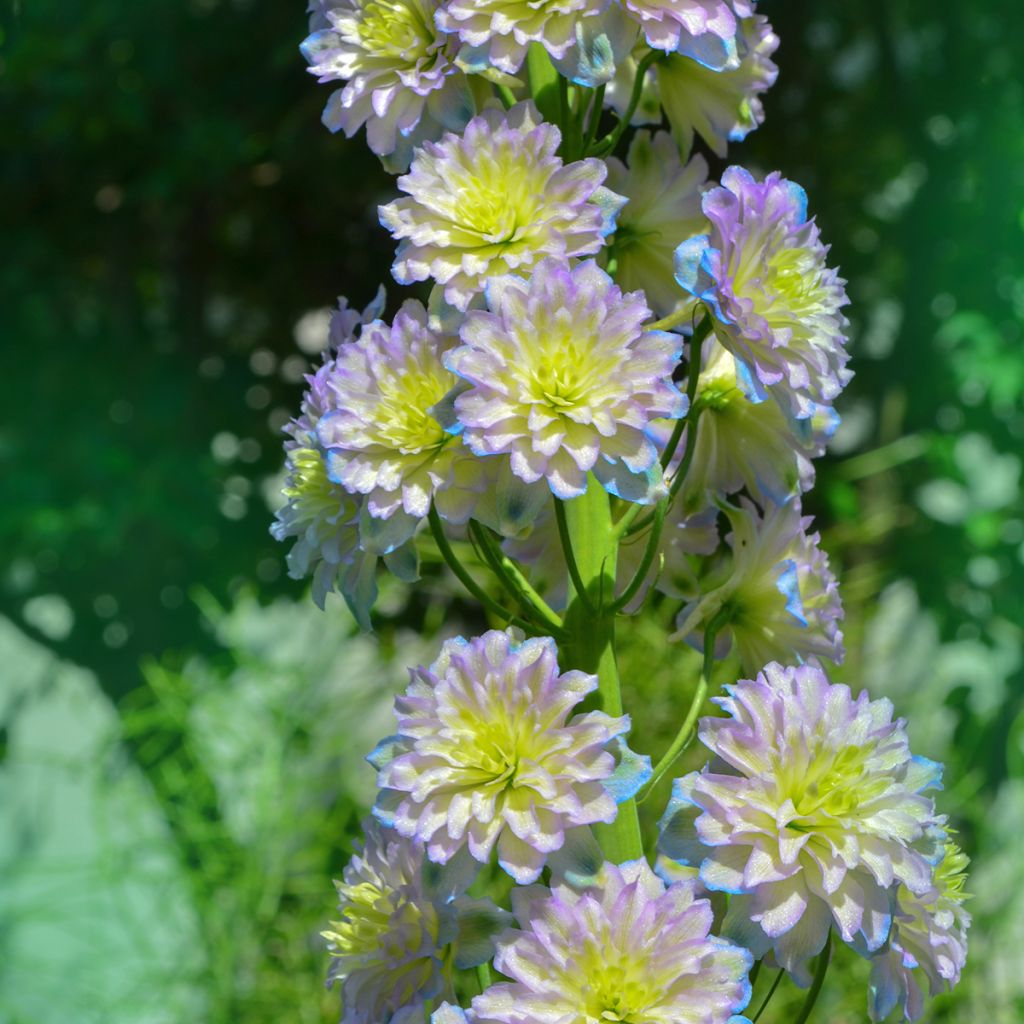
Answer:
[{"xmin": 680, "ymin": 338, "xmax": 839, "ymax": 514}]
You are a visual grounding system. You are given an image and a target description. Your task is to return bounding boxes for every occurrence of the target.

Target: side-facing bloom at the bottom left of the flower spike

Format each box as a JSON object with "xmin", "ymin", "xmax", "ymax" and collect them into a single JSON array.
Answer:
[{"xmin": 323, "ymin": 820, "xmax": 508, "ymax": 1024}]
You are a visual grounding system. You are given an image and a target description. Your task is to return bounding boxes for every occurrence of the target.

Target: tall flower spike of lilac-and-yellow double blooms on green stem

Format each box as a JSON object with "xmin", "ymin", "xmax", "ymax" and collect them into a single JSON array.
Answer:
[{"xmin": 273, "ymin": 8, "xmax": 969, "ymax": 1024}]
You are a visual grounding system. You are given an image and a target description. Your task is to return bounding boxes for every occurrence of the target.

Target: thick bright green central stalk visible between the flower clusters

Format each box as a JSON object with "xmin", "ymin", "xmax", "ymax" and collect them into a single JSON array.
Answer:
[{"xmin": 561, "ymin": 476, "xmax": 643, "ymax": 863}]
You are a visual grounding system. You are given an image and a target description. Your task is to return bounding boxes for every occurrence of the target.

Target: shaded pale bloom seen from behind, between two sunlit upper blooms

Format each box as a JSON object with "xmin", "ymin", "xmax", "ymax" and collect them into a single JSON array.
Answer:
[{"xmin": 607, "ymin": 131, "xmax": 708, "ymax": 316}]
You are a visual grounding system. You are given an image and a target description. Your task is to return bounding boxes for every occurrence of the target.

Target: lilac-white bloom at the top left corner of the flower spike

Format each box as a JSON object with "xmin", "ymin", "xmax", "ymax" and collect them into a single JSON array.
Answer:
[{"xmin": 302, "ymin": 0, "xmax": 473, "ymax": 166}]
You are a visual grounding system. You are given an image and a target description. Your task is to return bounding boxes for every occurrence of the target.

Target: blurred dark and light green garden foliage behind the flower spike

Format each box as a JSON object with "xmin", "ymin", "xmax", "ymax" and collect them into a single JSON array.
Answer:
[{"xmin": 0, "ymin": 0, "xmax": 1024, "ymax": 1024}]
